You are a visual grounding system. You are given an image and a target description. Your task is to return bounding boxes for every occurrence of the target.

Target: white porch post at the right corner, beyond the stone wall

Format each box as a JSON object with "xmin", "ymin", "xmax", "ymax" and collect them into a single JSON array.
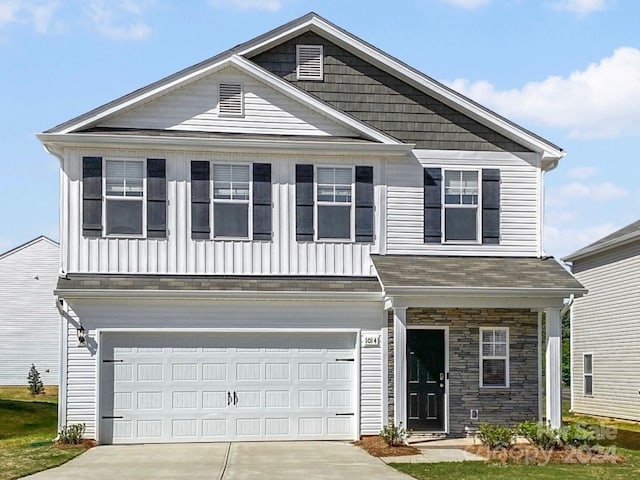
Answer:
[{"xmin": 545, "ymin": 308, "xmax": 562, "ymax": 428}]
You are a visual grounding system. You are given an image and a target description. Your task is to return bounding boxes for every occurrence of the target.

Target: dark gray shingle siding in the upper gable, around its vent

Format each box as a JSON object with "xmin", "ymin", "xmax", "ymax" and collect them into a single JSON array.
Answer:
[{"xmin": 251, "ymin": 32, "xmax": 530, "ymax": 152}]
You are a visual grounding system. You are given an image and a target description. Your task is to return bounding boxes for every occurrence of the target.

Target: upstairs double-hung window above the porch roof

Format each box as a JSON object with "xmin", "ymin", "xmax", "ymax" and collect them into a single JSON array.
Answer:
[{"xmin": 444, "ymin": 170, "xmax": 480, "ymax": 242}]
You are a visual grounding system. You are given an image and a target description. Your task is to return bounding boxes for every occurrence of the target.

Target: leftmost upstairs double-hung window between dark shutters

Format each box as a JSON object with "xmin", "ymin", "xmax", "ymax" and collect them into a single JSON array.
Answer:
[{"xmin": 104, "ymin": 160, "xmax": 144, "ymax": 235}]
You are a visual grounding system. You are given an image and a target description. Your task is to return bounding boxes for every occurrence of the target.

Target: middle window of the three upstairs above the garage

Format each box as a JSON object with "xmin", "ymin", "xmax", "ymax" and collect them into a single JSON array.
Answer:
[{"xmin": 213, "ymin": 165, "xmax": 250, "ymax": 238}]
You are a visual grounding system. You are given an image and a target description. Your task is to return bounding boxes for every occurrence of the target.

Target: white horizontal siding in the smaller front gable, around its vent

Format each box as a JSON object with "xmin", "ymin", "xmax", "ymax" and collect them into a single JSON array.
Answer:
[{"xmin": 98, "ymin": 68, "xmax": 354, "ymax": 137}]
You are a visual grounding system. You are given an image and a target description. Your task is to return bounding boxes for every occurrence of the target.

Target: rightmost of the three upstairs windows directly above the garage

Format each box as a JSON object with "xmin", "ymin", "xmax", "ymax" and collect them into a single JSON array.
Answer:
[{"xmin": 316, "ymin": 167, "xmax": 353, "ymax": 241}]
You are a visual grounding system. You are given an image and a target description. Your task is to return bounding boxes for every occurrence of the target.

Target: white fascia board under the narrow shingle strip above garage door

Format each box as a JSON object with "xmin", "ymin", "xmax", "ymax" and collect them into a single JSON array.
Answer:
[{"xmin": 54, "ymin": 289, "xmax": 383, "ymax": 302}]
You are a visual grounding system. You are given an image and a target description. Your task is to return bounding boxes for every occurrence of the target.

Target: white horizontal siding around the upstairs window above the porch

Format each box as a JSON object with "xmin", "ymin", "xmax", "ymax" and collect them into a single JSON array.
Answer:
[{"xmin": 386, "ymin": 150, "xmax": 542, "ymax": 256}]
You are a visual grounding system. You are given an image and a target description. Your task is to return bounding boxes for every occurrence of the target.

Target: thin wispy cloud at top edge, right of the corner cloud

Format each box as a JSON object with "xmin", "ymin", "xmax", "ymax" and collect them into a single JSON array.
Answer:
[{"xmin": 85, "ymin": 0, "xmax": 152, "ymax": 41}]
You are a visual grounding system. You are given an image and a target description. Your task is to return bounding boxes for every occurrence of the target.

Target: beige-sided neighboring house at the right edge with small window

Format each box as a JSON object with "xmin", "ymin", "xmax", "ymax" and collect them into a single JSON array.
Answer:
[{"xmin": 563, "ymin": 220, "xmax": 640, "ymax": 421}]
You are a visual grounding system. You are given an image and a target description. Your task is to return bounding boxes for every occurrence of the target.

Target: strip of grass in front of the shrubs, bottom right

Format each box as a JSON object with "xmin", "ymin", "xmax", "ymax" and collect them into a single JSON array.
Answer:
[{"xmin": 391, "ymin": 449, "xmax": 640, "ymax": 480}]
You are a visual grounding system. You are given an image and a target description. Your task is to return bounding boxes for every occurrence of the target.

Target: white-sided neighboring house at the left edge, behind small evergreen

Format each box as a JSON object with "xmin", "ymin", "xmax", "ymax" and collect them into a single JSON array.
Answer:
[{"xmin": 0, "ymin": 236, "xmax": 60, "ymax": 388}]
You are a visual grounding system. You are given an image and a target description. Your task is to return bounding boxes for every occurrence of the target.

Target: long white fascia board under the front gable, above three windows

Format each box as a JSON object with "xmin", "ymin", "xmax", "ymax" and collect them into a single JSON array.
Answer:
[{"xmin": 36, "ymin": 130, "xmax": 413, "ymax": 157}]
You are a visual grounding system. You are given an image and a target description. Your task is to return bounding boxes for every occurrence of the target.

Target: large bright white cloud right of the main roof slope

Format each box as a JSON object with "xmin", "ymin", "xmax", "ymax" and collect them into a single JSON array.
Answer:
[{"xmin": 450, "ymin": 47, "xmax": 640, "ymax": 138}]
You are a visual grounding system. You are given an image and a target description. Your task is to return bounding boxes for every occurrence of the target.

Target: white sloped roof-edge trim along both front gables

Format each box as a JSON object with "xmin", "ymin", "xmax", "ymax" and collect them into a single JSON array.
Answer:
[{"xmin": 39, "ymin": 12, "xmax": 565, "ymax": 165}]
